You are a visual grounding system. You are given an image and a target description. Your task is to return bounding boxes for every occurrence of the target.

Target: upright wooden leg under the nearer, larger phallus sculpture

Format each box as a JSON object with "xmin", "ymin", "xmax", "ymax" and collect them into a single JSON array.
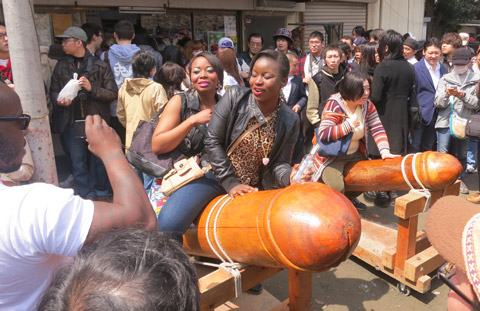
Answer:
[{"xmin": 288, "ymin": 269, "xmax": 312, "ymax": 311}]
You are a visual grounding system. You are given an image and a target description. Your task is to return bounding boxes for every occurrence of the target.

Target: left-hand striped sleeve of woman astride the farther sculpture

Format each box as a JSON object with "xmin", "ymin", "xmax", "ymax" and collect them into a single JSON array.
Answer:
[{"xmin": 319, "ymin": 99, "xmax": 353, "ymax": 142}]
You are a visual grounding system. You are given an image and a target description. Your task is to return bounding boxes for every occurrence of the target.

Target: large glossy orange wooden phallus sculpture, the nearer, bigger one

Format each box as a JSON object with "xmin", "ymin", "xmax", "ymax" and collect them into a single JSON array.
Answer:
[{"xmin": 184, "ymin": 182, "xmax": 360, "ymax": 272}]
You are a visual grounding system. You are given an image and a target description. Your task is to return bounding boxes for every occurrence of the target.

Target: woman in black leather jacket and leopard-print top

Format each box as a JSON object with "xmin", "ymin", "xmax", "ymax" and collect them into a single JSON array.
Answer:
[{"xmin": 205, "ymin": 50, "xmax": 299, "ymax": 198}]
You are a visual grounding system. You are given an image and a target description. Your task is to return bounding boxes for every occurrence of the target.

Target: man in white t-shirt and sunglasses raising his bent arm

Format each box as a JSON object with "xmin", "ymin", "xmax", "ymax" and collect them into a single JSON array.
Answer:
[{"xmin": 0, "ymin": 84, "xmax": 157, "ymax": 310}]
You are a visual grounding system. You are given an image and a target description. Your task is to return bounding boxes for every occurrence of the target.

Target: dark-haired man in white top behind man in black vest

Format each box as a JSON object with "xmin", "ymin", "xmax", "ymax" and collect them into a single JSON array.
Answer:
[{"xmin": 298, "ymin": 31, "xmax": 325, "ymax": 84}]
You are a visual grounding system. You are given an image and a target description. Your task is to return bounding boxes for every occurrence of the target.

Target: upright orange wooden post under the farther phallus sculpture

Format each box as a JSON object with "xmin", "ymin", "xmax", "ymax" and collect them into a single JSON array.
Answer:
[{"xmin": 395, "ymin": 215, "xmax": 418, "ymax": 273}]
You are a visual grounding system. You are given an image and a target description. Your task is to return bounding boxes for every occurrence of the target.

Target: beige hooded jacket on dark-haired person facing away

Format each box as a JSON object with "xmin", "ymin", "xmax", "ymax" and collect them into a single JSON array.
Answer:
[{"xmin": 117, "ymin": 78, "xmax": 168, "ymax": 148}]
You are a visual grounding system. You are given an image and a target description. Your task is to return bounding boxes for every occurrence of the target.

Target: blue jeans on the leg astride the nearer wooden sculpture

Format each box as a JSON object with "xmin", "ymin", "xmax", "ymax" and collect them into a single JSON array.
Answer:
[{"xmin": 158, "ymin": 172, "xmax": 225, "ymax": 241}]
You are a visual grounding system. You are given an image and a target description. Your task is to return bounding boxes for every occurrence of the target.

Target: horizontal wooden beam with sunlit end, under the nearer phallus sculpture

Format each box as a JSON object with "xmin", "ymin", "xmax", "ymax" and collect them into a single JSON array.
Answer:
[{"xmin": 198, "ymin": 266, "xmax": 282, "ymax": 311}]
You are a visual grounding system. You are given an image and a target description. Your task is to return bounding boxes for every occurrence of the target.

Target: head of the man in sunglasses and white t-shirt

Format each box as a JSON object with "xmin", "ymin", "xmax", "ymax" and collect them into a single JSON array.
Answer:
[{"xmin": 0, "ymin": 83, "xmax": 26, "ymax": 173}]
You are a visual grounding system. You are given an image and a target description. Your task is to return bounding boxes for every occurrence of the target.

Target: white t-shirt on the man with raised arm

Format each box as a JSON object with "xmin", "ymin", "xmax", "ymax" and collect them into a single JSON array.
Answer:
[{"xmin": 0, "ymin": 181, "xmax": 94, "ymax": 310}]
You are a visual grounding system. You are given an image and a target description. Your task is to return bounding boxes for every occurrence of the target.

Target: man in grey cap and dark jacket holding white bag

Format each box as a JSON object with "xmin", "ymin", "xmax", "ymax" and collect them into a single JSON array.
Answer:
[{"xmin": 50, "ymin": 27, "xmax": 118, "ymax": 200}]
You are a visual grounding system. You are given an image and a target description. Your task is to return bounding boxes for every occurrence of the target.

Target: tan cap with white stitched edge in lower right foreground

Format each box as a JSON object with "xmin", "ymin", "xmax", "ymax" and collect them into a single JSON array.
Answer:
[{"xmin": 425, "ymin": 196, "xmax": 480, "ymax": 299}]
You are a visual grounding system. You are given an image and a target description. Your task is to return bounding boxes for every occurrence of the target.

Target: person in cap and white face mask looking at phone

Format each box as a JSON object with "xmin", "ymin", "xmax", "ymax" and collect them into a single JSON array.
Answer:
[{"xmin": 435, "ymin": 48, "xmax": 480, "ymax": 194}]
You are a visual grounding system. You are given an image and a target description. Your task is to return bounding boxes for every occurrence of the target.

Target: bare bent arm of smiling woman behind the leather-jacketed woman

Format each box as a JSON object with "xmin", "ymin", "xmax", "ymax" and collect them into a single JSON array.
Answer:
[{"xmin": 152, "ymin": 95, "xmax": 212, "ymax": 154}]
